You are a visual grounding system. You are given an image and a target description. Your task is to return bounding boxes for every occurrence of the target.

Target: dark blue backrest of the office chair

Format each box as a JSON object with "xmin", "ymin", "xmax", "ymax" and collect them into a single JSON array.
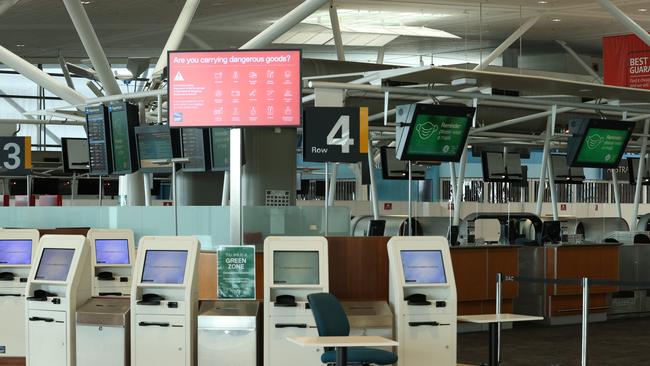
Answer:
[{"xmin": 307, "ymin": 292, "xmax": 350, "ymax": 337}]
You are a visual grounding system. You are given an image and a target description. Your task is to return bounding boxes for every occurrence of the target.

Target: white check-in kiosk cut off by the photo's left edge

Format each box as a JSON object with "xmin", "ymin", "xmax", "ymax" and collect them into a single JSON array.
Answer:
[{"xmin": 0, "ymin": 229, "xmax": 39, "ymax": 358}]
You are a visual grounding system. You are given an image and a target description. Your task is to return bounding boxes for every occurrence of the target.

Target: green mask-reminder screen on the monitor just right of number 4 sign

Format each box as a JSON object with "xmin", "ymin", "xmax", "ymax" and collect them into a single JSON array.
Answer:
[{"xmin": 407, "ymin": 114, "xmax": 469, "ymax": 156}]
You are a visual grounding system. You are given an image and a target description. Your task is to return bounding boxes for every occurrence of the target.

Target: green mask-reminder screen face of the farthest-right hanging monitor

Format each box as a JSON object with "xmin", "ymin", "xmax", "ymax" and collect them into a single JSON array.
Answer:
[{"xmin": 576, "ymin": 128, "xmax": 628, "ymax": 164}]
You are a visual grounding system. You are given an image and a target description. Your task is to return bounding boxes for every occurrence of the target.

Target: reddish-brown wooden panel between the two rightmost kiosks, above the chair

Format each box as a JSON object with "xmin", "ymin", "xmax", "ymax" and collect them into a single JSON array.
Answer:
[{"xmin": 327, "ymin": 237, "xmax": 390, "ymax": 301}]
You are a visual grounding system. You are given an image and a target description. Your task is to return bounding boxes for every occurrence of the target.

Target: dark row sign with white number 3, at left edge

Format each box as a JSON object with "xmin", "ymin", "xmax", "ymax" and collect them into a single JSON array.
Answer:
[{"xmin": 0, "ymin": 137, "xmax": 32, "ymax": 176}]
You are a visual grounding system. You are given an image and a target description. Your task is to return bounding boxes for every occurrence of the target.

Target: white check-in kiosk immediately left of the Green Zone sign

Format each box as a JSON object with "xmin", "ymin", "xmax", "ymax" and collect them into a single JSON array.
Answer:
[{"xmin": 131, "ymin": 236, "xmax": 199, "ymax": 366}]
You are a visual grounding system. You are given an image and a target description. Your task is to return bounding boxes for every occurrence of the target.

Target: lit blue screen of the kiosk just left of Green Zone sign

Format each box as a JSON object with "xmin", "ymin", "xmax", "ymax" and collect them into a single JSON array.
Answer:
[{"xmin": 142, "ymin": 250, "xmax": 187, "ymax": 285}]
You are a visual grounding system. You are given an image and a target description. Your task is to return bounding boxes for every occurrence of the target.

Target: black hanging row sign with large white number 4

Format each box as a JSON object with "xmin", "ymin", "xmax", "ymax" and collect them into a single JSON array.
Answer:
[{"xmin": 303, "ymin": 107, "xmax": 368, "ymax": 163}]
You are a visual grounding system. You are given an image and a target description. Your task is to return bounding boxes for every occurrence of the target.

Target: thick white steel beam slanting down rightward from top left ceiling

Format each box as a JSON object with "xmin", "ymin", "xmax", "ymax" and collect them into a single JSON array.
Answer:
[{"xmin": 63, "ymin": 0, "xmax": 122, "ymax": 95}]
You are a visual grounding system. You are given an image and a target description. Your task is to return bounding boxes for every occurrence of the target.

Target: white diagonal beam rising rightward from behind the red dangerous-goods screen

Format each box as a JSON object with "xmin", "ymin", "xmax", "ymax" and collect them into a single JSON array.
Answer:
[{"xmin": 241, "ymin": 0, "xmax": 330, "ymax": 50}]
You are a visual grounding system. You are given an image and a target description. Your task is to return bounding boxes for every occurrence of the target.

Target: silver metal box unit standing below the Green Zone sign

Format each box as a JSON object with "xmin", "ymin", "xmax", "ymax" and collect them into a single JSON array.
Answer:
[{"xmin": 197, "ymin": 300, "xmax": 262, "ymax": 366}]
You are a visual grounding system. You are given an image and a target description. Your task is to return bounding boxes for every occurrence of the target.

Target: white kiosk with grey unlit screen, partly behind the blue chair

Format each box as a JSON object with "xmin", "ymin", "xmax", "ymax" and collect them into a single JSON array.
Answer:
[{"xmin": 264, "ymin": 237, "xmax": 329, "ymax": 366}]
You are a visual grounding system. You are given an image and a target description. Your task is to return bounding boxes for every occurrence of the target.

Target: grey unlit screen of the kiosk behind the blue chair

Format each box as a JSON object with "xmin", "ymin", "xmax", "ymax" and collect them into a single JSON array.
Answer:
[{"xmin": 273, "ymin": 251, "xmax": 320, "ymax": 285}]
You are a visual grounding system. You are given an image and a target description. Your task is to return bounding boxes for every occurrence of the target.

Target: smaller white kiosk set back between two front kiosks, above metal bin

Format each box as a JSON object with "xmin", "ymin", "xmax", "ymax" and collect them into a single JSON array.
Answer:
[{"xmin": 87, "ymin": 229, "xmax": 135, "ymax": 297}]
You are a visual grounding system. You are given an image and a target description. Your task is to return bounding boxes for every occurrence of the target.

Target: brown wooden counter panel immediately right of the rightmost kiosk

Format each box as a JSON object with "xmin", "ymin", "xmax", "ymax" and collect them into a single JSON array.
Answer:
[{"xmin": 451, "ymin": 249, "xmax": 488, "ymax": 302}]
